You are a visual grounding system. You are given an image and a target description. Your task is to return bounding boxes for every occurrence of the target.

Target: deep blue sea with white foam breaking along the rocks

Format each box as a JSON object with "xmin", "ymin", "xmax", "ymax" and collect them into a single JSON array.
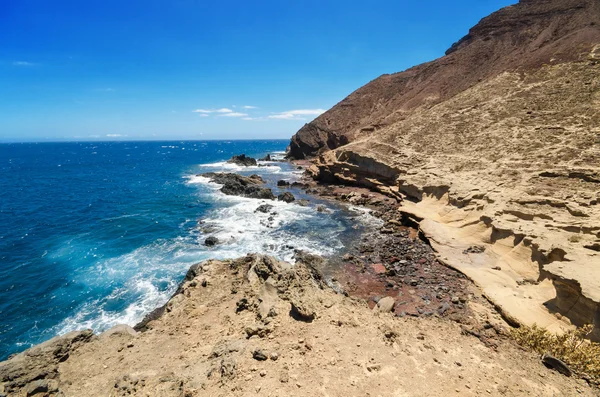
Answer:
[{"xmin": 0, "ymin": 141, "xmax": 370, "ymax": 360}]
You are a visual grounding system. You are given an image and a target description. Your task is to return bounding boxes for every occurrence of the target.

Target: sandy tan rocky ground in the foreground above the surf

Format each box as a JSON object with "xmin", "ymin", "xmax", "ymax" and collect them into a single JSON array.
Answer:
[{"xmin": 0, "ymin": 255, "xmax": 595, "ymax": 397}]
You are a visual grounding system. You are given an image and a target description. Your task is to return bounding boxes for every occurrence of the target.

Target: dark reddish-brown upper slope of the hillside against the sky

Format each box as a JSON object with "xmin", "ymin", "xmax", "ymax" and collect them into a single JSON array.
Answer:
[{"xmin": 288, "ymin": 0, "xmax": 600, "ymax": 159}]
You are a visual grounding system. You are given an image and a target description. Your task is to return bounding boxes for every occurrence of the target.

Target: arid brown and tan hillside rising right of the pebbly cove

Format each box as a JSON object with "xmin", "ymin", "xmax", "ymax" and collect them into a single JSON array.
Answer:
[{"xmin": 289, "ymin": 0, "xmax": 600, "ymax": 339}]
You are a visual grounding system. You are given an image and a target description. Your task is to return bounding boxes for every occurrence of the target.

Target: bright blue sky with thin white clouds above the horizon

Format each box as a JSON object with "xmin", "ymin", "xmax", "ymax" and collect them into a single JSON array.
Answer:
[{"xmin": 0, "ymin": 0, "xmax": 516, "ymax": 141}]
